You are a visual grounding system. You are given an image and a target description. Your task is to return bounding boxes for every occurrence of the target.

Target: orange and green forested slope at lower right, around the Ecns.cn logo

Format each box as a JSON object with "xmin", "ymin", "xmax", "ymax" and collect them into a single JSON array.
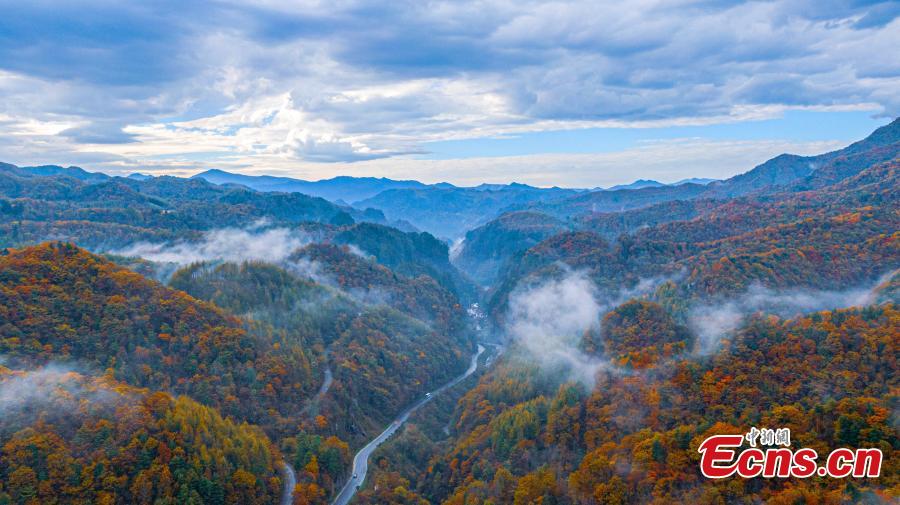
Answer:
[{"xmin": 372, "ymin": 305, "xmax": 900, "ymax": 504}]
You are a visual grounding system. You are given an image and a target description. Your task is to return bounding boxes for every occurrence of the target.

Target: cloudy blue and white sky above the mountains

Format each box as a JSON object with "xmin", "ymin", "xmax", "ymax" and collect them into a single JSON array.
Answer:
[{"xmin": 0, "ymin": 0, "xmax": 900, "ymax": 187}]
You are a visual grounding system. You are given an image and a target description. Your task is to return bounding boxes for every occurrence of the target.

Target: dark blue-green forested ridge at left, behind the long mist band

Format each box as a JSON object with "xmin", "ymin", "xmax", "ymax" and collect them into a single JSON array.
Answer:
[{"xmin": 0, "ymin": 165, "xmax": 386, "ymax": 249}]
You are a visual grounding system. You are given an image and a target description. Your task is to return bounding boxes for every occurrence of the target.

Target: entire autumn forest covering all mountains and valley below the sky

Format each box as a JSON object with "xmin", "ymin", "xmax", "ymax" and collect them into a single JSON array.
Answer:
[{"xmin": 0, "ymin": 120, "xmax": 900, "ymax": 505}]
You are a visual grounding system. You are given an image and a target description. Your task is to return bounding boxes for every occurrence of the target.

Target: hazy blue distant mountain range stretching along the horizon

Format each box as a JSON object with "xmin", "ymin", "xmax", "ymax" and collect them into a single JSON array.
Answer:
[{"xmin": 8, "ymin": 120, "xmax": 900, "ymax": 240}]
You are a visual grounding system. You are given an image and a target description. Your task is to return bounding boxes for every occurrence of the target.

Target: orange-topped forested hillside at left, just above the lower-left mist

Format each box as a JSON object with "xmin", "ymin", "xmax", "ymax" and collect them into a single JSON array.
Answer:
[{"xmin": 0, "ymin": 242, "xmax": 314, "ymax": 429}]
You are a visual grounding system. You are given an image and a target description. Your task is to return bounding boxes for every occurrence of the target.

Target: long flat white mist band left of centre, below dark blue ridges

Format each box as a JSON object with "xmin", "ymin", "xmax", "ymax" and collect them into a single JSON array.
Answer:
[{"xmin": 114, "ymin": 226, "xmax": 309, "ymax": 265}]
